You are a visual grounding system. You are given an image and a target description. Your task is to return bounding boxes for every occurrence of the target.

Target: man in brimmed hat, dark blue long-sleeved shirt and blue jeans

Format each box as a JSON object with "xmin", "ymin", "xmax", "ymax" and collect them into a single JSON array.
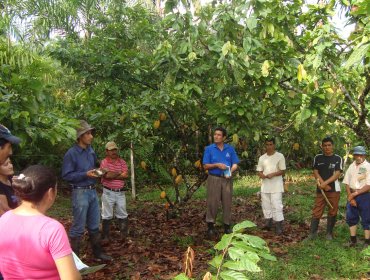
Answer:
[{"xmin": 62, "ymin": 121, "xmax": 112, "ymax": 261}]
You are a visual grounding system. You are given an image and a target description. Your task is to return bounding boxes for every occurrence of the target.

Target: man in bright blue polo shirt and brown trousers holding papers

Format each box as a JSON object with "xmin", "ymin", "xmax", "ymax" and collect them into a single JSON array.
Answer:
[{"xmin": 203, "ymin": 127, "xmax": 239, "ymax": 238}]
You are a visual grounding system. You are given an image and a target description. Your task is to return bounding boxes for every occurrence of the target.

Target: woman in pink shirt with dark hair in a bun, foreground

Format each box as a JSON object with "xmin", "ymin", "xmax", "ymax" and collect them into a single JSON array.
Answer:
[{"xmin": 0, "ymin": 165, "xmax": 81, "ymax": 280}]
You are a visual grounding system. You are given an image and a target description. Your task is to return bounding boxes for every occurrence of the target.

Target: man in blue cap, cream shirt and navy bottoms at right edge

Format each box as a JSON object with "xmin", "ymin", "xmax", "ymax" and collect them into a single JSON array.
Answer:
[{"xmin": 343, "ymin": 146, "xmax": 370, "ymax": 247}]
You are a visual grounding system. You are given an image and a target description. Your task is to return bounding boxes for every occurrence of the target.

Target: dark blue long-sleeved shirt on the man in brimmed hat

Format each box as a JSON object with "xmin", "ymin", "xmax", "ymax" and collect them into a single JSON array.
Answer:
[{"xmin": 62, "ymin": 144, "xmax": 98, "ymax": 187}]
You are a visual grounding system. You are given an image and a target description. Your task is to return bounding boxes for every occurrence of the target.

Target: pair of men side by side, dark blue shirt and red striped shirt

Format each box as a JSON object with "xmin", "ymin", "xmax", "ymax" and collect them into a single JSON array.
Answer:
[{"xmin": 62, "ymin": 121, "xmax": 128, "ymax": 261}]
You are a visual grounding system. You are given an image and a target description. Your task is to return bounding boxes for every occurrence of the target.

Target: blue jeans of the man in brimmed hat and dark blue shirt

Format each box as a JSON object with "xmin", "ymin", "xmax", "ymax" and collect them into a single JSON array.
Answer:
[{"xmin": 69, "ymin": 189, "xmax": 100, "ymax": 238}]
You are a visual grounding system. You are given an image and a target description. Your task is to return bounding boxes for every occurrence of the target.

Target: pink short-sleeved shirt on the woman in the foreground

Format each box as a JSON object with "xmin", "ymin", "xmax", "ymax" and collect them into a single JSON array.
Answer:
[{"xmin": 0, "ymin": 210, "xmax": 72, "ymax": 280}]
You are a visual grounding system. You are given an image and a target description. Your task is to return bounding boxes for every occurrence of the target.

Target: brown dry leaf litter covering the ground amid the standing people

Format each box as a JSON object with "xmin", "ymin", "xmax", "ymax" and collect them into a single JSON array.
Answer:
[{"xmin": 61, "ymin": 194, "xmax": 309, "ymax": 280}]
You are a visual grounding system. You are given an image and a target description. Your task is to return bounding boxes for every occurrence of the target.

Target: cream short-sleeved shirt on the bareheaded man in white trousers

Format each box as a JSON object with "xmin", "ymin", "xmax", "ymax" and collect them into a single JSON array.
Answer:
[{"xmin": 257, "ymin": 152, "xmax": 286, "ymax": 193}]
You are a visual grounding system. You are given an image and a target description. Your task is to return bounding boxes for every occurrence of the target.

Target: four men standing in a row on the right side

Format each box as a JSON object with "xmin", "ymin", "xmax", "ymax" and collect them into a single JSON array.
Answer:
[{"xmin": 203, "ymin": 127, "xmax": 370, "ymax": 247}]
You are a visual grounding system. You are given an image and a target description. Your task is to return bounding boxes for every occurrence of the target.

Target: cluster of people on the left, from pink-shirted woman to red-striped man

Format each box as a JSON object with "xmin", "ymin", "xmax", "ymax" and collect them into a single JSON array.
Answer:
[{"xmin": 0, "ymin": 121, "xmax": 128, "ymax": 280}]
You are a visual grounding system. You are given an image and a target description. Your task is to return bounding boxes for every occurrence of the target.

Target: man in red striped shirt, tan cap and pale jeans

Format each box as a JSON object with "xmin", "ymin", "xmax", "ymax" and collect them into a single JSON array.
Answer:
[{"xmin": 100, "ymin": 141, "xmax": 128, "ymax": 240}]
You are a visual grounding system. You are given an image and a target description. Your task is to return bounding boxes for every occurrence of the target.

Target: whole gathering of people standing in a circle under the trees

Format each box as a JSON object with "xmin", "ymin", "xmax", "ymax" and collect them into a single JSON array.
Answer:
[{"xmin": 0, "ymin": 121, "xmax": 370, "ymax": 280}]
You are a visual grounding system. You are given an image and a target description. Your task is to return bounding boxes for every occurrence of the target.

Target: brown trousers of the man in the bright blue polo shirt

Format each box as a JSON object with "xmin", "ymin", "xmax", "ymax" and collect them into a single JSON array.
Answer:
[{"xmin": 206, "ymin": 175, "xmax": 233, "ymax": 225}]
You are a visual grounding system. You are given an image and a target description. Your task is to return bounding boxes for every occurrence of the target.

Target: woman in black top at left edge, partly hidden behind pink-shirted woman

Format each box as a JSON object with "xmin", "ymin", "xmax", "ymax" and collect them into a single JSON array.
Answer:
[{"xmin": 0, "ymin": 158, "xmax": 18, "ymax": 216}]
